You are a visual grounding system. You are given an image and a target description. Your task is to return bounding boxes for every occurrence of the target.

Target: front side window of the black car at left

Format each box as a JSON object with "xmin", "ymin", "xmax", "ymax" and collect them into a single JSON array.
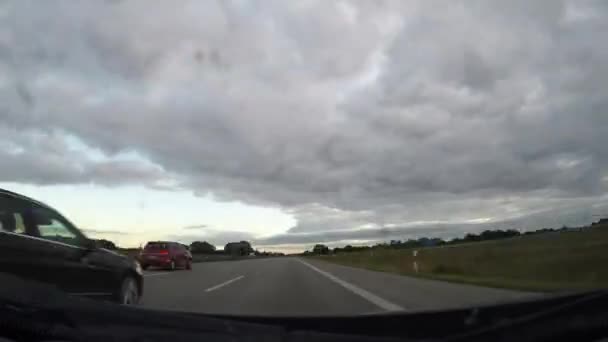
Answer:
[{"xmin": 32, "ymin": 208, "xmax": 83, "ymax": 246}]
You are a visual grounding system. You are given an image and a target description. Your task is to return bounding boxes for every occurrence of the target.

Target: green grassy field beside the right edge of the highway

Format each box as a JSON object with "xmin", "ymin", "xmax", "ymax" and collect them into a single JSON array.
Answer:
[{"xmin": 315, "ymin": 227, "xmax": 608, "ymax": 291}]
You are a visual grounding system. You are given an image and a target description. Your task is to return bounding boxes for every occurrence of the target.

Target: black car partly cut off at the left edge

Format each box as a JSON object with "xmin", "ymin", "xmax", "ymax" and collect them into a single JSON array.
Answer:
[{"xmin": 0, "ymin": 189, "xmax": 143, "ymax": 304}]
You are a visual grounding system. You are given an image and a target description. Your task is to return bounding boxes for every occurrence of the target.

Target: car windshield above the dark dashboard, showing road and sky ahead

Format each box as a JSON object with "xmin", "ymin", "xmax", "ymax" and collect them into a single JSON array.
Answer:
[{"xmin": 0, "ymin": 0, "xmax": 608, "ymax": 317}]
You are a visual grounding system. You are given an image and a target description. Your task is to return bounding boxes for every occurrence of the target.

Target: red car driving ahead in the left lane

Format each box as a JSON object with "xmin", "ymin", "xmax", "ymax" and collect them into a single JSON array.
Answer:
[{"xmin": 139, "ymin": 241, "xmax": 192, "ymax": 270}]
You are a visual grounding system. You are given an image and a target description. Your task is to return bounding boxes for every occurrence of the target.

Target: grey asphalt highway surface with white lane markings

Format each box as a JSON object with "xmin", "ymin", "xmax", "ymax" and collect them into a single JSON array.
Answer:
[{"xmin": 142, "ymin": 257, "xmax": 538, "ymax": 316}]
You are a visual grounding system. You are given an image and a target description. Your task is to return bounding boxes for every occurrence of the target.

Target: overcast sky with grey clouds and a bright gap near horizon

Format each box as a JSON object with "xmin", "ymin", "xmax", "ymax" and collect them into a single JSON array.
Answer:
[{"xmin": 0, "ymin": 0, "xmax": 608, "ymax": 250}]
